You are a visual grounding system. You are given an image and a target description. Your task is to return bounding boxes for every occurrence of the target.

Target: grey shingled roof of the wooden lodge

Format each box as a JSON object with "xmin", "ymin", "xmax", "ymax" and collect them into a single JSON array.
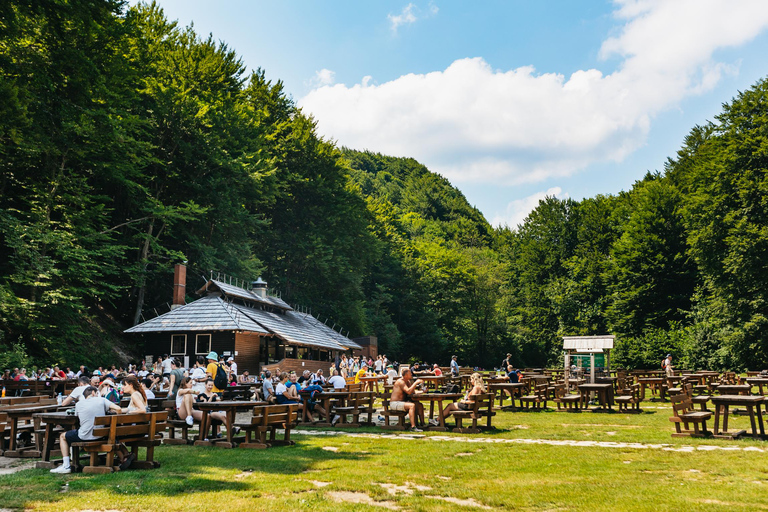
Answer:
[{"xmin": 124, "ymin": 280, "xmax": 362, "ymax": 350}]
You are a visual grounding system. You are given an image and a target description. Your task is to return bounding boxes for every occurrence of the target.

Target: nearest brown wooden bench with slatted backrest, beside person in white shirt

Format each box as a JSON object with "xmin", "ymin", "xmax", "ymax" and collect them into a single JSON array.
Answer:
[{"xmin": 72, "ymin": 412, "xmax": 168, "ymax": 473}]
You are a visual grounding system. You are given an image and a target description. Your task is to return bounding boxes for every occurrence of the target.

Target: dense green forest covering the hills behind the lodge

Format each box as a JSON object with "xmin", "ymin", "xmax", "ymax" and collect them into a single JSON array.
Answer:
[{"xmin": 0, "ymin": 0, "xmax": 768, "ymax": 369}]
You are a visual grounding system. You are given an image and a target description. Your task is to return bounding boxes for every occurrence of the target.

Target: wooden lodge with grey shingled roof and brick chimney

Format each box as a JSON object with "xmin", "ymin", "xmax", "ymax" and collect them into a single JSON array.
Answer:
[{"xmin": 125, "ymin": 265, "xmax": 362, "ymax": 374}]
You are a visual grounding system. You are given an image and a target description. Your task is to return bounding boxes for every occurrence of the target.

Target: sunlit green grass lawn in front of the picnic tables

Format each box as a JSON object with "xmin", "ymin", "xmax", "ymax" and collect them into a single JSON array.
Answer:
[{"xmin": 0, "ymin": 402, "xmax": 768, "ymax": 512}]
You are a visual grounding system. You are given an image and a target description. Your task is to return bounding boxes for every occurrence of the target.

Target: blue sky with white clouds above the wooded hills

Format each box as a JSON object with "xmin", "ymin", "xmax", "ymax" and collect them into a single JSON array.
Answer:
[{"xmin": 141, "ymin": 0, "xmax": 768, "ymax": 228}]
